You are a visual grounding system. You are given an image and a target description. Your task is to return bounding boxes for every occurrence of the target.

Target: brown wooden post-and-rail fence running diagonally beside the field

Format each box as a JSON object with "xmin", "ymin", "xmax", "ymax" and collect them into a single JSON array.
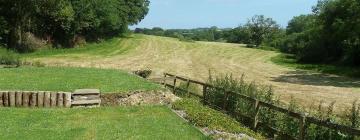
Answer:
[{"xmin": 161, "ymin": 73, "xmax": 360, "ymax": 140}]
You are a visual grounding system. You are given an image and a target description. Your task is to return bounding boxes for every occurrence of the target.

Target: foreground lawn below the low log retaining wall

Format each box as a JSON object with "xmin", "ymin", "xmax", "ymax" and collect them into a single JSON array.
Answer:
[{"xmin": 0, "ymin": 106, "xmax": 206, "ymax": 140}]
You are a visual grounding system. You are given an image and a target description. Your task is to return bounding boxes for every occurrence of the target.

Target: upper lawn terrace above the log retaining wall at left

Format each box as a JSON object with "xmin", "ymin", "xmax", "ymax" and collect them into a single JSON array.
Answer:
[{"xmin": 0, "ymin": 67, "xmax": 161, "ymax": 93}]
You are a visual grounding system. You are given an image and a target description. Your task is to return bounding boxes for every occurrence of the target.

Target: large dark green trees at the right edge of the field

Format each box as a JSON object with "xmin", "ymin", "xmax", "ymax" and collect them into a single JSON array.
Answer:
[{"xmin": 280, "ymin": 0, "xmax": 360, "ymax": 66}]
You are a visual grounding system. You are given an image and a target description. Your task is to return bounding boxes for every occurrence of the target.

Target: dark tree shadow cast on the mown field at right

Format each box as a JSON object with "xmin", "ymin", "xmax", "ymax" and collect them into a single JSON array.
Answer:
[{"xmin": 272, "ymin": 70, "xmax": 360, "ymax": 88}]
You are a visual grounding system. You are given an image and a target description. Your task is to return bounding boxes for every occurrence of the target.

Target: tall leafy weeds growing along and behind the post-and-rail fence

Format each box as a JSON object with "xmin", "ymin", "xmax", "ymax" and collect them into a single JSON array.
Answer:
[{"xmin": 205, "ymin": 75, "xmax": 360, "ymax": 140}]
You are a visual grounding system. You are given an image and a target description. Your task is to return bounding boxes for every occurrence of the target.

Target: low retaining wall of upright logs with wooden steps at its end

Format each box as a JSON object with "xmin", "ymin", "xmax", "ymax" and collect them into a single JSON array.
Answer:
[{"xmin": 0, "ymin": 89, "xmax": 101, "ymax": 108}]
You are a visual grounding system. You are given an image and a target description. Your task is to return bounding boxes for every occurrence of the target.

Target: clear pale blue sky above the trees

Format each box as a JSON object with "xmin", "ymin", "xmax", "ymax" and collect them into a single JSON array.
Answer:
[{"xmin": 131, "ymin": 0, "xmax": 317, "ymax": 29}]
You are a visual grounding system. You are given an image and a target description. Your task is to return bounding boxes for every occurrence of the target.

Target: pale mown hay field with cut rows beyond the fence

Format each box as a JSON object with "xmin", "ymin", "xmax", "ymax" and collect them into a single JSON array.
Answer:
[{"xmin": 12, "ymin": 35, "xmax": 360, "ymax": 112}]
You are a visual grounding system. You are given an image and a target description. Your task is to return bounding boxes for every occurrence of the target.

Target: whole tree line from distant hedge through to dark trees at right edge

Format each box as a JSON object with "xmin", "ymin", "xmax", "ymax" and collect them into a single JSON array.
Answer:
[{"xmin": 135, "ymin": 0, "xmax": 360, "ymax": 66}]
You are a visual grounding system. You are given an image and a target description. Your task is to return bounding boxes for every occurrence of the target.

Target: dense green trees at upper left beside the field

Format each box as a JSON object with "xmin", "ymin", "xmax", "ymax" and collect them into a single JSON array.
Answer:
[{"xmin": 0, "ymin": 0, "xmax": 149, "ymax": 52}]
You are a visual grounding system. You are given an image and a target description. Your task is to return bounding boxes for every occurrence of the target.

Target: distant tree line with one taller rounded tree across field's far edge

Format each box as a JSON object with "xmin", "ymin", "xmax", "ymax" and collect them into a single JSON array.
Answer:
[{"xmin": 134, "ymin": 15, "xmax": 283, "ymax": 47}]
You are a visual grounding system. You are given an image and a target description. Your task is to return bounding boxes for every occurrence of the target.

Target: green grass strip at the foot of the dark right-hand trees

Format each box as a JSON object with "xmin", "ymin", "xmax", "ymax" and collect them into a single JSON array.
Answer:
[{"xmin": 271, "ymin": 54, "xmax": 360, "ymax": 78}]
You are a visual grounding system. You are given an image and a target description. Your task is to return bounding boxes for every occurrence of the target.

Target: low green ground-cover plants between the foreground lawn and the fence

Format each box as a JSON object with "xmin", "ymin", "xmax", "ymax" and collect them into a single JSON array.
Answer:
[{"xmin": 173, "ymin": 98, "xmax": 264, "ymax": 139}]
